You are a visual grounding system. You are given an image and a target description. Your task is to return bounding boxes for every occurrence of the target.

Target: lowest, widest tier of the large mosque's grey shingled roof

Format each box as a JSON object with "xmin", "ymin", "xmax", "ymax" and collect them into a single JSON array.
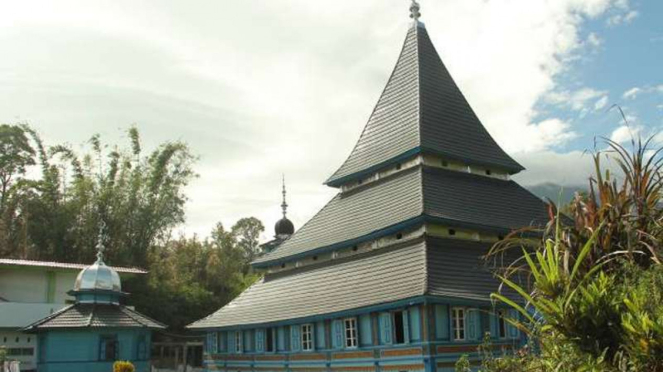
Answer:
[{"xmin": 189, "ymin": 238, "xmax": 516, "ymax": 329}]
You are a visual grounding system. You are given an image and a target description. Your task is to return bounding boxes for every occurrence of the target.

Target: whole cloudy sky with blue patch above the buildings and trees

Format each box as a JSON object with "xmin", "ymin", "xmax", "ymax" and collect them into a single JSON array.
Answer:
[{"xmin": 0, "ymin": 0, "xmax": 663, "ymax": 239}]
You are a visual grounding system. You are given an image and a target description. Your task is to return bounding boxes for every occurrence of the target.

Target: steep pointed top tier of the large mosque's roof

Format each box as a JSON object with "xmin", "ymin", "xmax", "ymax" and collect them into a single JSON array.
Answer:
[{"xmin": 326, "ymin": 23, "xmax": 524, "ymax": 186}]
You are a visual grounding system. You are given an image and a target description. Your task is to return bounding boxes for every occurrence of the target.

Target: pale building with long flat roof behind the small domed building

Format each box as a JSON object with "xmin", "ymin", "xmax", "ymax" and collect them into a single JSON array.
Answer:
[{"xmin": 0, "ymin": 258, "xmax": 146, "ymax": 371}]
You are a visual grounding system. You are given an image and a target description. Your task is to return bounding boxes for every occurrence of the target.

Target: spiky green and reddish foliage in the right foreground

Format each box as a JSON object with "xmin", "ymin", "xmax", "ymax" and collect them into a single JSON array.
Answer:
[{"xmin": 482, "ymin": 137, "xmax": 663, "ymax": 372}]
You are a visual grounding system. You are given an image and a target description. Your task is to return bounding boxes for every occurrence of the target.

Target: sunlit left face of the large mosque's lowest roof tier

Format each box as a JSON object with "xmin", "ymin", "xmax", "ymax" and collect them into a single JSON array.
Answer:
[{"xmin": 190, "ymin": 240, "xmax": 426, "ymax": 328}]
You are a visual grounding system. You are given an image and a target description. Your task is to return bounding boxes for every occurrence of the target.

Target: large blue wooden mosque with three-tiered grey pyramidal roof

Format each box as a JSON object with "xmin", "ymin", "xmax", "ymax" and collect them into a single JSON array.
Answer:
[{"xmin": 189, "ymin": 1, "xmax": 548, "ymax": 372}]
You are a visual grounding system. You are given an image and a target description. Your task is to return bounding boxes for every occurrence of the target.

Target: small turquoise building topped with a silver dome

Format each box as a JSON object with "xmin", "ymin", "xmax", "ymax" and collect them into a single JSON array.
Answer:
[{"xmin": 24, "ymin": 238, "xmax": 165, "ymax": 372}]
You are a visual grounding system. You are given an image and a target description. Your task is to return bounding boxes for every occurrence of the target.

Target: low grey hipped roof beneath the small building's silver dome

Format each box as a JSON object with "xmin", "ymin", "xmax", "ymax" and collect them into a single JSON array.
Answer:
[{"xmin": 24, "ymin": 303, "xmax": 166, "ymax": 332}]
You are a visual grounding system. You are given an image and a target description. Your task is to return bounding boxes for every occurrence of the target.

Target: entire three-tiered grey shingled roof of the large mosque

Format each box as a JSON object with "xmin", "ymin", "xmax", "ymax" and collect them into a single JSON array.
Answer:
[{"xmin": 191, "ymin": 3, "xmax": 548, "ymax": 328}]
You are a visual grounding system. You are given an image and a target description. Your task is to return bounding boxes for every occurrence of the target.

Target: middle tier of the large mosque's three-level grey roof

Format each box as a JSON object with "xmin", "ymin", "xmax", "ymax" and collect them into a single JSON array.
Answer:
[{"xmin": 254, "ymin": 167, "xmax": 548, "ymax": 266}]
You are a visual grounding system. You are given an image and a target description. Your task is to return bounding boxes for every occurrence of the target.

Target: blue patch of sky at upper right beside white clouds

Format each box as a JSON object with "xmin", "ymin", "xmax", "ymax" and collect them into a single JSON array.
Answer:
[{"xmin": 538, "ymin": 0, "xmax": 663, "ymax": 151}]
